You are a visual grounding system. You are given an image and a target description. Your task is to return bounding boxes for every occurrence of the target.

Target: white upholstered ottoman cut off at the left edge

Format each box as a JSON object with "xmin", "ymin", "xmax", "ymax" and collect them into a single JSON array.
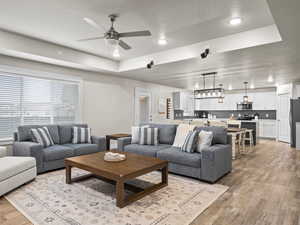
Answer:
[{"xmin": 0, "ymin": 156, "xmax": 36, "ymax": 196}]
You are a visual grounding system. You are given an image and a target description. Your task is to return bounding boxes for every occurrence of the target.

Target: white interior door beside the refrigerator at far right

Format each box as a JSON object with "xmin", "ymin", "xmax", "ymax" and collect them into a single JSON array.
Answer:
[{"xmin": 277, "ymin": 94, "xmax": 290, "ymax": 143}]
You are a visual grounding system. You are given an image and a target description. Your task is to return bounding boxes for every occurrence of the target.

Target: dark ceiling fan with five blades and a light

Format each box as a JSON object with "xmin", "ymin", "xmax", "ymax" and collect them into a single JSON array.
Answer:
[{"xmin": 78, "ymin": 14, "xmax": 151, "ymax": 50}]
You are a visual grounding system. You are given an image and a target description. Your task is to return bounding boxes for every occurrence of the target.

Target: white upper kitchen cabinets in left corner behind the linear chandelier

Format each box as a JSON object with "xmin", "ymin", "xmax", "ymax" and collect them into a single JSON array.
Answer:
[{"xmin": 173, "ymin": 91, "xmax": 195, "ymax": 116}]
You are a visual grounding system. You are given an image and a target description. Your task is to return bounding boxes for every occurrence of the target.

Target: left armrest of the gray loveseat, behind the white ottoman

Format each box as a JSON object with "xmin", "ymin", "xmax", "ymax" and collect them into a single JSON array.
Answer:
[{"xmin": 13, "ymin": 141, "xmax": 43, "ymax": 172}]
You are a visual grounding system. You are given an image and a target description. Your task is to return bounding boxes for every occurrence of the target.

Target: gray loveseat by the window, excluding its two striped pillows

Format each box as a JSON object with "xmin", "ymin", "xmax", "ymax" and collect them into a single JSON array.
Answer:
[{"xmin": 13, "ymin": 124, "xmax": 106, "ymax": 173}]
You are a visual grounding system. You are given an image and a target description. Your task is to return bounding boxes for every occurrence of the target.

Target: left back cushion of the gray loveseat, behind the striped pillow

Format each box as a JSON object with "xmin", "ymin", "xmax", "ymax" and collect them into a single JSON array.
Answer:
[{"xmin": 17, "ymin": 125, "xmax": 60, "ymax": 144}]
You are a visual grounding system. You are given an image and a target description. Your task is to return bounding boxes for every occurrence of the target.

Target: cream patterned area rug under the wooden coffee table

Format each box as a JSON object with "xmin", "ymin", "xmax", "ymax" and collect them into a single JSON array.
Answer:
[{"xmin": 6, "ymin": 169, "xmax": 228, "ymax": 225}]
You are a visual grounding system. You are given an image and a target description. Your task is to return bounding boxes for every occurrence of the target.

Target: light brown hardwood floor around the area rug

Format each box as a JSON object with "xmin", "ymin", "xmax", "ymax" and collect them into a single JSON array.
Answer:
[{"xmin": 0, "ymin": 140, "xmax": 300, "ymax": 225}]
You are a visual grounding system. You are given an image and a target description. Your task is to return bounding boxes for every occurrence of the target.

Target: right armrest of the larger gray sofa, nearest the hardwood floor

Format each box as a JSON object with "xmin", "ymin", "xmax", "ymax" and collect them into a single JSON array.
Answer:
[{"xmin": 201, "ymin": 144, "xmax": 232, "ymax": 183}]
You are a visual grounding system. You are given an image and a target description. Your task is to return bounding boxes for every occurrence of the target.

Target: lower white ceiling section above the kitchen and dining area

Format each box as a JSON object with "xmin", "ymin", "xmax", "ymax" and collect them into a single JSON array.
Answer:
[{"xmin": 121, "ymin": 42, "xmax": 300, "ymax": 89}]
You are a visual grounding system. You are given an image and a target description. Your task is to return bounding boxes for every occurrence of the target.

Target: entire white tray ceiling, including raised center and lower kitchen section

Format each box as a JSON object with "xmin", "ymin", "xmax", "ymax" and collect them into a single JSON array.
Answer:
[{"xmin": 0, "ymin": 0, "xmax": 300, "ymax": 89}]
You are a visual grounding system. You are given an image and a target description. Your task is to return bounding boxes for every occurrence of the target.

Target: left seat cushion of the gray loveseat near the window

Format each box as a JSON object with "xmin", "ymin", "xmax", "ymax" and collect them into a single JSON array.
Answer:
[{"xmin": 42, "ymin": 145, "xmax": 74, "ymax": 161}]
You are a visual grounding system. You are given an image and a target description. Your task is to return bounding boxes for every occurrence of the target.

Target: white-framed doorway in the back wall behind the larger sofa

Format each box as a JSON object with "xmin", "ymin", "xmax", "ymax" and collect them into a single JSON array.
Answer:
[{"xmin": 134, "ymin": 88, "xmax": 152, "ymax": 125}]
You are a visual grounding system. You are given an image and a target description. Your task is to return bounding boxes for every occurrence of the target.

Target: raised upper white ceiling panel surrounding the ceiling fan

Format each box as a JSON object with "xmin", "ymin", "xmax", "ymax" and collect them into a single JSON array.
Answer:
[{"xmin": 0, "ymin": 0, "xmax": 274, "ymax": 60}]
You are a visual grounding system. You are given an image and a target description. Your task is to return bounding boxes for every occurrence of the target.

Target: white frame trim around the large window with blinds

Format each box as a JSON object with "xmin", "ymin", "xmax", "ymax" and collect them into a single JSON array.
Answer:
[{"xmin": 0, "ymin": 65, "xmax": 83, "ymax": 145}]
